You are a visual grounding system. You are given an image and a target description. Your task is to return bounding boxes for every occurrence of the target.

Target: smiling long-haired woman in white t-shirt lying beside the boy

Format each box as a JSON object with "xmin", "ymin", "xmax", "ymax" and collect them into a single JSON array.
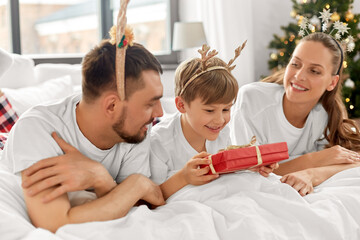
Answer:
[{"xmin": 231, "ymin": 32, "xmax": 360, "ymax": 196}]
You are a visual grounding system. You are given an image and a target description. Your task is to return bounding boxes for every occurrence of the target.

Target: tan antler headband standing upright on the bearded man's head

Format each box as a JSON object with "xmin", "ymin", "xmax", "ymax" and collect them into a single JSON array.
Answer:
[{"xmin": 114, "ymin": 0, "xmax": 134, "ymax": 100}]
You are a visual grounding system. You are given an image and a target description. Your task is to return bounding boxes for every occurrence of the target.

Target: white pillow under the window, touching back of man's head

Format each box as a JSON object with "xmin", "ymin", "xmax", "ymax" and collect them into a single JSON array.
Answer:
[{"xmin": 35, "ymin": 63, "xmax": 82, "ymax": 85}]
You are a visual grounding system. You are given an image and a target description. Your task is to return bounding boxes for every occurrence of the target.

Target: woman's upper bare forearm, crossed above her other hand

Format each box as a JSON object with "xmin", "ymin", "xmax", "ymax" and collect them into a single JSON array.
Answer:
[{"xmin": 274, "ymin": 145, "xmax": 360, "ymax": 175}]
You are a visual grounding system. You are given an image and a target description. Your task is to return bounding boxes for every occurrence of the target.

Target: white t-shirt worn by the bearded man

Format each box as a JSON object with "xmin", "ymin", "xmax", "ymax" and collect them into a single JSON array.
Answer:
[{"xmin": 1, "ymin": 95, "xmax": 150, "ymax": 183}]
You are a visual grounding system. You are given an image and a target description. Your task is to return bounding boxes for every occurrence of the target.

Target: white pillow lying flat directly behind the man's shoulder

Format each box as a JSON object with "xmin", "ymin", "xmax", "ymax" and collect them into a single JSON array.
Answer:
[{"xmin": 1, "ymin": 76, "xmax": 73, "ymax": 116}]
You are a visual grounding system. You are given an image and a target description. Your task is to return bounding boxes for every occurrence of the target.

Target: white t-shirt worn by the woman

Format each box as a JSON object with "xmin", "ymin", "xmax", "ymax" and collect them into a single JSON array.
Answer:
[{"xmin": 230, "ymin": 82, "xmax": 328, "ymax": 162}]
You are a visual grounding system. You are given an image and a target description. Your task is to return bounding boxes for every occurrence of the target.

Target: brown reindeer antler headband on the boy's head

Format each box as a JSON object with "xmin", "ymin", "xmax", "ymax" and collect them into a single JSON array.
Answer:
[{"xmin": 179, "ymin": 41, "xmax": 247, "ymax": 96}]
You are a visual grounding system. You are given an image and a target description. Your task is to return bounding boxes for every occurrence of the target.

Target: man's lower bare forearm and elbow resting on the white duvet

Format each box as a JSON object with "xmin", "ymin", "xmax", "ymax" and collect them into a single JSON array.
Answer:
[{"xmin": 22, "ymin": 173, "xmax": 164, "ymax": 232}]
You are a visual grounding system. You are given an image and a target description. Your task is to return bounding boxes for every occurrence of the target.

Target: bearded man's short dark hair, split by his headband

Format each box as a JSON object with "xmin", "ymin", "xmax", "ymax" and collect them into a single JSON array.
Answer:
[{"xmin": 82, "ymin": 40, "xmax": 162, "ymax": 102}]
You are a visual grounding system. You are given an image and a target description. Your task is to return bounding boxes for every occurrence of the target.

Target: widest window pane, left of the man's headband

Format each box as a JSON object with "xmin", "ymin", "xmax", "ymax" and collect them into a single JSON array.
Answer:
[{"xmin": 19, "ymin": 0, "xmax": 99, "ymax": 54}]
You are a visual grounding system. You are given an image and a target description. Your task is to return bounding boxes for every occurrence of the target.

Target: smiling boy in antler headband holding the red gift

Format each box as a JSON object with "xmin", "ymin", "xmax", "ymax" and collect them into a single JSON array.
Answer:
[{"xmin": 150, "ymin": 44, "xmax": 276, "ymax": 199}]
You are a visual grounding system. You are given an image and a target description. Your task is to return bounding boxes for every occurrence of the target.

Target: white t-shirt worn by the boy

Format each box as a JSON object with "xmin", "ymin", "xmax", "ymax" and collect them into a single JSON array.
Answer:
[{"xmin": 150, "ymin": 113, "xmax": 231, "ymax": 184}]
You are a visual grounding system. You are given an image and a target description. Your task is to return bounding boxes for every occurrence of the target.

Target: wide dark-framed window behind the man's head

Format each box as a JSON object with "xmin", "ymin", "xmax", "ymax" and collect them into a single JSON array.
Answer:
[{"xmin": 5, "ymin": 0, "xmax": 177, "ymax": 64}]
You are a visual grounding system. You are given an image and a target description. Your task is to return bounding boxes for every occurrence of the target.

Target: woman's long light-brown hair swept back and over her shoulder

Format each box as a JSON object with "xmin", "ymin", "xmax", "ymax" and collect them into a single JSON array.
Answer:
[{"xmin": 262, "ymin": 32, "xmax": 360, "ymax": 151}]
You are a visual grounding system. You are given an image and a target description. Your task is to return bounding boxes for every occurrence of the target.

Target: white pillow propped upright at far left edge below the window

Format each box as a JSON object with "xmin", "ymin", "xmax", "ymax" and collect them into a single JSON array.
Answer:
[{"xmin": 0, "ymin": 54, "xmax": 38, "ymax": 88}]
